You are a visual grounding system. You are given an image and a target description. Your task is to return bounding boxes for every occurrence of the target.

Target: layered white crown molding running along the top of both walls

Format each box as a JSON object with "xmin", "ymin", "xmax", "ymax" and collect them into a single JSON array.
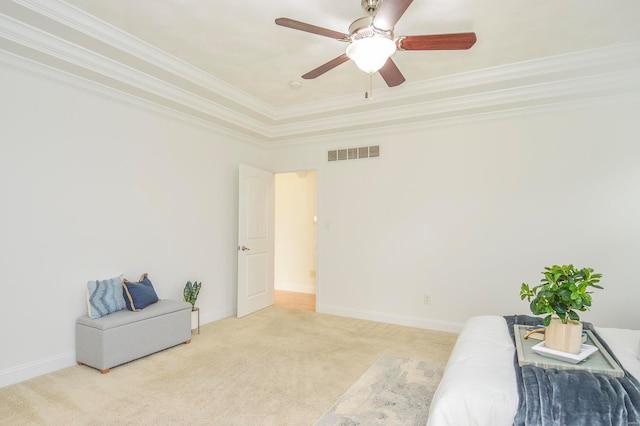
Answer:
[{"xmin": 0, "ymin": 0, "xmax": 640, "ymax": 147}]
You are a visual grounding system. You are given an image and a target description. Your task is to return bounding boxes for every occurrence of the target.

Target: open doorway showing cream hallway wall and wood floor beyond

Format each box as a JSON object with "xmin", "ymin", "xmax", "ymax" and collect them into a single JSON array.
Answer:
[{"xmin": 274, "ymin": 170, "xmax": 318, "ymax": 311}]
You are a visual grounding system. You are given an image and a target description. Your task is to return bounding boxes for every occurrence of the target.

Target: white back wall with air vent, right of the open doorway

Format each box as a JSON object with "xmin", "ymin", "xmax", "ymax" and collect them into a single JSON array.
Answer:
[{"xmin": 274, "ymin": 95, "xmax": 640, "ymax": 330}]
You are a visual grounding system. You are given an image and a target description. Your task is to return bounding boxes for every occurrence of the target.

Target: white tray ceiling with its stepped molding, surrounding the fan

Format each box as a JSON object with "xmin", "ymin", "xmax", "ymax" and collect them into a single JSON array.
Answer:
[{"xmin": 0, "ymin": 0, "xmax": 640, "ymax": 145}]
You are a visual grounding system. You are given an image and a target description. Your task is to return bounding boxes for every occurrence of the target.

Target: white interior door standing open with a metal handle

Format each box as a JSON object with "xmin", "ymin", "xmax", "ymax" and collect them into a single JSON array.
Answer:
[{"xmin": 237, "ymin": 164, "xmax": 275, "ymax": 318}]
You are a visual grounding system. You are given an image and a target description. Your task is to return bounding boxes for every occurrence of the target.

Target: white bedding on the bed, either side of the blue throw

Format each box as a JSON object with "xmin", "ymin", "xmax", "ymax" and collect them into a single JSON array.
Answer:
[{"xmin": 428, "ymin": 316, "xmax": 640, "ymax": 426}]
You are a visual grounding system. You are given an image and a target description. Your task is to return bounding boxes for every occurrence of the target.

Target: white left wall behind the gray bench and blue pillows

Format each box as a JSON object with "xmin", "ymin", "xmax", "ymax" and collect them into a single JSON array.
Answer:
[{"xmin": 0, "ymin": 68, "xmax": 268, "ymax": 386}]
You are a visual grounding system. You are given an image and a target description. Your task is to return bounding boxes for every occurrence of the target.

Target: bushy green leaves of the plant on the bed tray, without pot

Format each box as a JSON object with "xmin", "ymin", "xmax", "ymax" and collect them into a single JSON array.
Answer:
[{"xmin": 520, "ymin": 265, "xmax": 603, "ymax": 326}]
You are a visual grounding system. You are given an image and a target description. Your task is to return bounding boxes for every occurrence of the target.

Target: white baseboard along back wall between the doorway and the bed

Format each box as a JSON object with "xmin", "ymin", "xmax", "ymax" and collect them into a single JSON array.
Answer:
[{"xmin": 316, "ymin": 305, "xmax": 464, "ymax": 334}]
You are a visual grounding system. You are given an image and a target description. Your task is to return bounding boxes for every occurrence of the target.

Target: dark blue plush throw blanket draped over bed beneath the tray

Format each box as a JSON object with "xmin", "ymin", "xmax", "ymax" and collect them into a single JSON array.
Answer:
[{"xmin": 505, "ymin": 315, "xmax": 640, "ymax": 426}]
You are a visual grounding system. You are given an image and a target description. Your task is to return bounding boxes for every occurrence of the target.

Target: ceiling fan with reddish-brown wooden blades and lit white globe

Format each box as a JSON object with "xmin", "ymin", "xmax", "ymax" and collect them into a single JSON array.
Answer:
[{"xmin": 276, "ymin": 0, "xmax": 476, "ymax": 87}]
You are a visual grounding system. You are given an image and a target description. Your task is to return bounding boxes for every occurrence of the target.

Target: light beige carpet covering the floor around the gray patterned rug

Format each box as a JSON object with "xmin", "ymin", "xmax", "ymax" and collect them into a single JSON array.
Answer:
[{"xmin": 0, "ymin": 307, "xmax": 456, "ymax": 426}]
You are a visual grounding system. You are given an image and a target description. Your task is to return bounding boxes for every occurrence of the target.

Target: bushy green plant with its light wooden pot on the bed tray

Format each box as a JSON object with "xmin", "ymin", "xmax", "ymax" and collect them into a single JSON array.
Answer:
[{"xmin": 520, "ymin": 265, "xmax": 603, "ymax": 354}]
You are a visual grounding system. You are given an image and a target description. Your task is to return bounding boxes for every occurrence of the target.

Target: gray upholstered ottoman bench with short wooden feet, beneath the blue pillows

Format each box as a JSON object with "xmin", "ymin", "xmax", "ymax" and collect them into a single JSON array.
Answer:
[{"xmin": 76, "ymin": 300, "xmax": 191, "ymax": 374}]
